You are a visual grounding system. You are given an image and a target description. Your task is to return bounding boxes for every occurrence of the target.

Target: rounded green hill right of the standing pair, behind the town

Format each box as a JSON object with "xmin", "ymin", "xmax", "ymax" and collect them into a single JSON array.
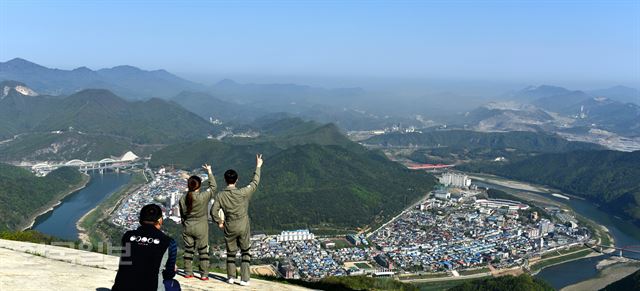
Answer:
[{"xmin": 251, "ymin": 144, "xmax": 434, "ymax": 230}]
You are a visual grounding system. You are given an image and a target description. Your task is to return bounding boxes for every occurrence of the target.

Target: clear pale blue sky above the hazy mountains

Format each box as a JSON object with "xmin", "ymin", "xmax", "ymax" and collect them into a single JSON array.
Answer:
[{"xmin": 0, "ymin": 0, "xmax": 640, "ymax": 85}]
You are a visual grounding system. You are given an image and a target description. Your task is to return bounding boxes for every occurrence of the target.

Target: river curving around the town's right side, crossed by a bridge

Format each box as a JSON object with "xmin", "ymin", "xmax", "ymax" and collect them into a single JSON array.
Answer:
[{"xmin": 474, "ymin": 182, "xmax": 640, "ymax": 289}]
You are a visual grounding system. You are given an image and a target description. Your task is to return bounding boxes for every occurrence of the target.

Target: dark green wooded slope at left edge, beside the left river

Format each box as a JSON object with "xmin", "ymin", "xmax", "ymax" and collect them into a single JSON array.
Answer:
[{"xmin": 0, "ymin": 163, "xmax": 83, "ymax": 230}]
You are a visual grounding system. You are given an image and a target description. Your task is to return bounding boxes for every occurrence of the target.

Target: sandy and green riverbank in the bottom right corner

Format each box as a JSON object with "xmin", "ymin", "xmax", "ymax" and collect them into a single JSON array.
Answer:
[{"xmin": 560, "ymin": 258, "xmax": 640, "ymax": 291}]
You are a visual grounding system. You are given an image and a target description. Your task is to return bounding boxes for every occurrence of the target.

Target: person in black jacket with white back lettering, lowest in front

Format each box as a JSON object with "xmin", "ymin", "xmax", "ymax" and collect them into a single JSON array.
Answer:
[{"xmin": 111, "ymin": 204, "xmax": 180, "ymax": 291}]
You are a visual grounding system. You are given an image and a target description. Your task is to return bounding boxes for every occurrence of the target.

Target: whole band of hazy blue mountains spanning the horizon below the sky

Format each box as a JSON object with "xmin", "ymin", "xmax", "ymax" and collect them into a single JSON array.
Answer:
[{"xmin": 0, "ymin": 58, "xmax": 640, "ymax": 137}]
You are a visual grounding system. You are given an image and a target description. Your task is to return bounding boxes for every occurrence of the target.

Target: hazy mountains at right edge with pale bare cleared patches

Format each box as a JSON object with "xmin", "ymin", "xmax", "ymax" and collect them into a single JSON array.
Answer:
[{"xmin": 459, "ymin": 85, "xmax": 640, "ymax": 137}]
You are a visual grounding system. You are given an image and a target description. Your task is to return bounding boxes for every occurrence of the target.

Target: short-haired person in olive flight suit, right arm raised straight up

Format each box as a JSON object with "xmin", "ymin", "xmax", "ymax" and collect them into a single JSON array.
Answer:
[{"xmin": 211, "ymin": 154, "xmax": 262, "ymax": 286}]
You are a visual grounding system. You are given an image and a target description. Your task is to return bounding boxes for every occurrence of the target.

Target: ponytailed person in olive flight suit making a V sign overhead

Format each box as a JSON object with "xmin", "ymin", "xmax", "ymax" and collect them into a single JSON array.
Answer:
[{"xmin": 179, "ymin": 164, "xmax": 217, "ymax": 280}]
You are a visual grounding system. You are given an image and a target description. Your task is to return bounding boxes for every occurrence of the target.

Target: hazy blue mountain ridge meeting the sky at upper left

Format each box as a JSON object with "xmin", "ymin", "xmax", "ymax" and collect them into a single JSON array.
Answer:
[{"xmin": 0, "ymin": 58, "xmax": 205, "ymax": 99}]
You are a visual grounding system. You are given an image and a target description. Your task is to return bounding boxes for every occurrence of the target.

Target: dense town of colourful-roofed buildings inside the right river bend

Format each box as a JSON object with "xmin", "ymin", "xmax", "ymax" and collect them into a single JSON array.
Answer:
[{"xmin": 370, "ymin": 192, "xmax": 589, "ymax": 271}]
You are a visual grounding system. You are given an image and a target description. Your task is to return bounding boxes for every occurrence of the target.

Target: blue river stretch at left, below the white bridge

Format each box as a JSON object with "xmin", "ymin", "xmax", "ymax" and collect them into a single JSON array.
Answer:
[{"xmin": 32, "ymin": 172, "xmax": 131, "ymax": 240}]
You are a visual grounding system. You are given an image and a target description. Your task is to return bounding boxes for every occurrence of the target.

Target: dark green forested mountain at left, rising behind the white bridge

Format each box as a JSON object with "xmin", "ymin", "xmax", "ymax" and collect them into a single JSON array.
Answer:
[{"xmin": 0, "ymin": 89, "xmax": 216, "ymax": 143}]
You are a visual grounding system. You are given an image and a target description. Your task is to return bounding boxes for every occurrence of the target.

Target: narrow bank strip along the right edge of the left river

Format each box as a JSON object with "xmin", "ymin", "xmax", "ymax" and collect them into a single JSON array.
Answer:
[{"xmin": 76, "ymin": 171, "xmax": 145, "ymax": 244}]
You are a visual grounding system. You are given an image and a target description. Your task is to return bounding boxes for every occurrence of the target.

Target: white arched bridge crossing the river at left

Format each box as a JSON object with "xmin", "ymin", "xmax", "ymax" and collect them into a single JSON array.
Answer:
[{"xmin": 31, "ymin": 151, "xmax": 140, "ymax": 176}]
